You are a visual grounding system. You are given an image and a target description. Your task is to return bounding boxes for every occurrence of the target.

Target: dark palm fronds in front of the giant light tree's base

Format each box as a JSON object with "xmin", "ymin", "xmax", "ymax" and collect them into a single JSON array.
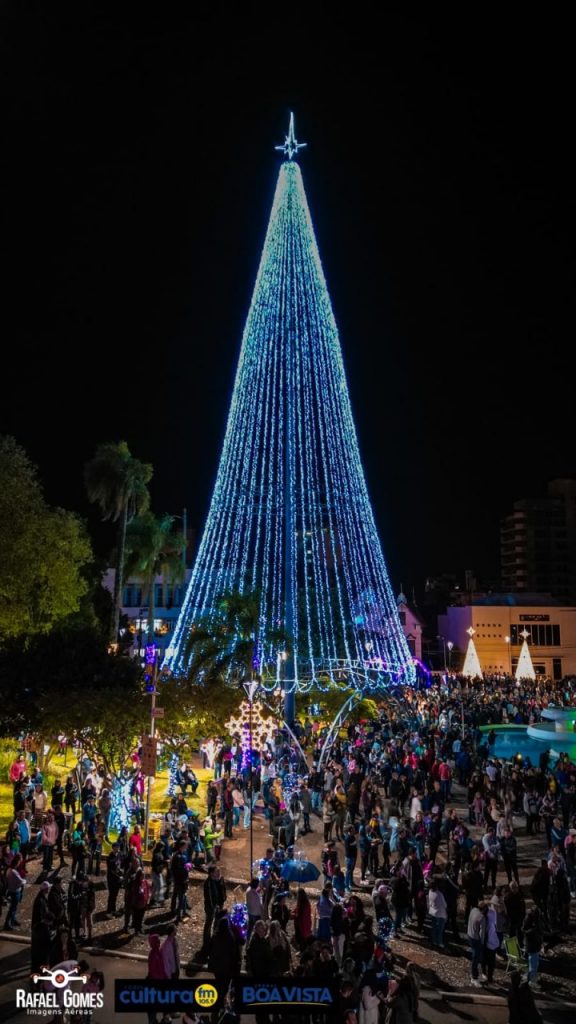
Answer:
[{"xmin": 184, "ymin": 591, "xmax": 290, "ymax": 683}]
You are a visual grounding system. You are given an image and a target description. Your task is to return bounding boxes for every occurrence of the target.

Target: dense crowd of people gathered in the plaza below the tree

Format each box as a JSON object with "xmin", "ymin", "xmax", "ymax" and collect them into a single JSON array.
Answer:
[{"xmin": 0, "ymin": 676, "xmax": 576, "ymax": 1024}]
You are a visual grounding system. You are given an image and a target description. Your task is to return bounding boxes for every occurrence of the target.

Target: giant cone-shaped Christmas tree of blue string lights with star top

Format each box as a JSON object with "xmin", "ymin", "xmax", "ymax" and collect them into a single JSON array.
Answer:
[{"xmin": 166, "ymin": 119, "xmax": 415, "ymax": 692}]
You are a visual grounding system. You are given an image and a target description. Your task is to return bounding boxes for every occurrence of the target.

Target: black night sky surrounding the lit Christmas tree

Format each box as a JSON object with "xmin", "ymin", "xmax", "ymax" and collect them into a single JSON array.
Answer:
[{"xmin": 0, "ymin": 4, "xmax": 576, "ymax": 589}]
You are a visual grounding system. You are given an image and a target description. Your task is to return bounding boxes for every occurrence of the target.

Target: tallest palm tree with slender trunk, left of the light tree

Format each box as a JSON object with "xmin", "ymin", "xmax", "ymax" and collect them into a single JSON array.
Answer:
[{"xmin": 84, "ymin": 441, "xmax": 154, "ymax": 644}]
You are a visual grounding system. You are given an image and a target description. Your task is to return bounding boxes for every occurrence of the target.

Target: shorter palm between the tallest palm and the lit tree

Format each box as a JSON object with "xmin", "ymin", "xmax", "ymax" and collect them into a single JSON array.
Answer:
[{"xmin": 126, "ymin": 511, "xmax": 187, "ymax": 644}]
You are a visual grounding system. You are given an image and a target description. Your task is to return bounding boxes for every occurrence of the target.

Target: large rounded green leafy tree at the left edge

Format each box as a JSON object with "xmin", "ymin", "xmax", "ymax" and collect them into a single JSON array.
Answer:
[{"xmin": 0, "ymin": 437, "xmax": 92, "ymax": 642}]
